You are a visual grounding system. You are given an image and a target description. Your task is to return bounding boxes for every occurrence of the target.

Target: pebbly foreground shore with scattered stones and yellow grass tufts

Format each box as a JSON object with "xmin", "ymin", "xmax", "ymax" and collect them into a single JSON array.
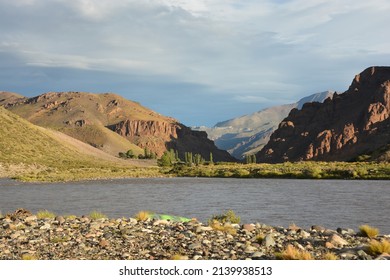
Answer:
[{"xmin": 0, "ymin": 209, "xmax": 390, "ymax": 260}]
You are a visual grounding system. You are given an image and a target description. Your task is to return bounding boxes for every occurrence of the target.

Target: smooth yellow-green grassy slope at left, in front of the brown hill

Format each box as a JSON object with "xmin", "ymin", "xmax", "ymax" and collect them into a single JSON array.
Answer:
[{"xmin": 0, "ymin": 107, "xmax": 158, "ymax": 181}]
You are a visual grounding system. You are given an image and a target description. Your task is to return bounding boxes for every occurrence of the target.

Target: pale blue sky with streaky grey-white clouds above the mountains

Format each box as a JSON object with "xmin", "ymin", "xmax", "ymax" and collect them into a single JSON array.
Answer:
[{"xmin": 0, "ymin": 0, "xmax": 390, "ymax": 126}]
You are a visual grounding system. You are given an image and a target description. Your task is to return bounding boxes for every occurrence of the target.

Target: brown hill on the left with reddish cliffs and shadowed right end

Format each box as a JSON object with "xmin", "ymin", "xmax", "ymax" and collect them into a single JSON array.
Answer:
[{"xmin": 0, "ymin": 92, "xmax": 232, "ymax": 161}]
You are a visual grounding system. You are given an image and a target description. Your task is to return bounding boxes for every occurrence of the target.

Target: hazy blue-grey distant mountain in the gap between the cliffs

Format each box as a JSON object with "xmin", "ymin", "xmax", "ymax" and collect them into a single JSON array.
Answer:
[{"xmin": 193, "ymin": 91, "xmax": 335, "ymax": 159}]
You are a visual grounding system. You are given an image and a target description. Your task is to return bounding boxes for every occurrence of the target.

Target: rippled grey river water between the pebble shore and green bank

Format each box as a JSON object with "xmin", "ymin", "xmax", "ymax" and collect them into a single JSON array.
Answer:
[{"xmin": 0, "ymin": 178, "xmax": 390, "ymax": 234}]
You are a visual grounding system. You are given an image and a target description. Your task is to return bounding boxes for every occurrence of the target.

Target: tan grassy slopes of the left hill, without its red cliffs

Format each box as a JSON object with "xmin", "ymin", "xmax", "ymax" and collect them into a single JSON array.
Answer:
[{"xmin": 0, "ymin": 92, "xmax": 174, "ymax": 156}]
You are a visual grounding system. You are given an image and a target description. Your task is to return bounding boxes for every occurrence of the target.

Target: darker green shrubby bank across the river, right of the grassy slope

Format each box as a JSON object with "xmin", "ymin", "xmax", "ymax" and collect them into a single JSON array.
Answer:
[{"xmin": 167, "ymin": 161, "xmax": 390, "ymax": 180}]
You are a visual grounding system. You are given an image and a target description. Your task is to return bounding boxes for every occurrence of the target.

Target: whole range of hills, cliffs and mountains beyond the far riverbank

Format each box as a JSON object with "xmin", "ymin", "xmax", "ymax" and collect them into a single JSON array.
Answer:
[{"xmin": 0, "ymin": 67, "xmax": 390, "ymax": 170}]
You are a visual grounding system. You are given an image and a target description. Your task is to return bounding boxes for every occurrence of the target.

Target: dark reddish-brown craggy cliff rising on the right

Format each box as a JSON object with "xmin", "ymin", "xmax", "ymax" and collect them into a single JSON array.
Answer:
[{"xmin": 257, "ymin": 67, "xmax": 390, "ymax": 163}]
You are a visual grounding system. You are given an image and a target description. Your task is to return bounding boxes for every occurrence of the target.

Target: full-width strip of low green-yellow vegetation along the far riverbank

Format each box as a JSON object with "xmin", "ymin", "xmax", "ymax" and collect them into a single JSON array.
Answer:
[{"xmin": 0, "ymin": 159, "xmax": 390, "ymax": 182}]
